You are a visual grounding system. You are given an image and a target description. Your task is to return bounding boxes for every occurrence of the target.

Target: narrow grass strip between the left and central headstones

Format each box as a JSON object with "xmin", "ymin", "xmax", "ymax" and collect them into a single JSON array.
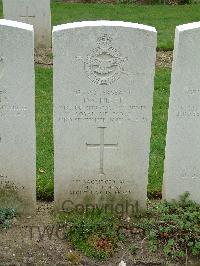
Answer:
[{"xmin": 36, "ymin": 67, "xmax": 53, "ymax": 200}]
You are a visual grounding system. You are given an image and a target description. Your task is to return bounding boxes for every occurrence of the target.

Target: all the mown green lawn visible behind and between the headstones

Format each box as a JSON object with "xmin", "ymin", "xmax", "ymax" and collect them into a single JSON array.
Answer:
[{"xmin": 0, "ymin": 0, "xmax": 184, "ymax": 199}]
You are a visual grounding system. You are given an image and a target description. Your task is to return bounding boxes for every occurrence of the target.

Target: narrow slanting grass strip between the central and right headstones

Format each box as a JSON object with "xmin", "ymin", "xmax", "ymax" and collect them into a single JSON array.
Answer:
[{"xmin": 148, "ymin": 68, "xmax": 171, "ymax": 195}]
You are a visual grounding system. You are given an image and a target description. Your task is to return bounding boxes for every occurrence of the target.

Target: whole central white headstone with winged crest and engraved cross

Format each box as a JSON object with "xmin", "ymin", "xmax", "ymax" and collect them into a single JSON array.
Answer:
[{"xmin": 53, "ymin": 21, "xmax": 156, "ymax": 214}]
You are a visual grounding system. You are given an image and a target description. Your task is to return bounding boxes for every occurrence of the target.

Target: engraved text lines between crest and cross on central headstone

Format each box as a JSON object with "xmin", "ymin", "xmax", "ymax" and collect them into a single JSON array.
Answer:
[{"xmin": 58, "ymin": 89, "xmax": 147, "ymax": 123}]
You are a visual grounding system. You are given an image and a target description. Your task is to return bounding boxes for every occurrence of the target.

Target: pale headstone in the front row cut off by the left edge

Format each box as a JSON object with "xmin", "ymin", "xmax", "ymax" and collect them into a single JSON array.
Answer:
[{"xmin": 0, "ymin": 20, "xmax": 36, "ymax": 212}]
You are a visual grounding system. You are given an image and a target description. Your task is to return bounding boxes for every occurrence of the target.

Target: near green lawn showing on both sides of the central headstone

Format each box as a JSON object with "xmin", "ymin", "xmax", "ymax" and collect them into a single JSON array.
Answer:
[{"xmin": 36, "ymin": 67, "xmax": 170, "ymax": 199}]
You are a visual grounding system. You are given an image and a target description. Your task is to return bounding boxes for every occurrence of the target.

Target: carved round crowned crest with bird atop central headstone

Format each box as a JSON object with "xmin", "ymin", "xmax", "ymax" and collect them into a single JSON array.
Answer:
[{"xmin": 79, "ymin": 34, "xmax": 127, "ymax": 85}]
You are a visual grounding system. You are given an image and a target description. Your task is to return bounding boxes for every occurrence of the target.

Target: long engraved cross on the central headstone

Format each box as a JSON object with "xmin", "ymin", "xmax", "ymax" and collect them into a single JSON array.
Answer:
[{"xmin": 86, "ymin": 127, "xmax": 118, "ymax": 175}]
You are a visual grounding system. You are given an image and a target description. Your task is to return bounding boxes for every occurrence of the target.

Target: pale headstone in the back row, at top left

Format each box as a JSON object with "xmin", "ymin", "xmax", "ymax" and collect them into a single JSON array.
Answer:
[{"xmin": 3, "ymin": 0, "xmax": 51, "ymax": 48}]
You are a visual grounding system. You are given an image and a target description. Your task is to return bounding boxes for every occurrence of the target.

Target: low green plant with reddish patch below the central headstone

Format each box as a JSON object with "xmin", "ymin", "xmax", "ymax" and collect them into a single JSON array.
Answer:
[{"xmin": 55, "ymin": 209, "xmax": 123, "ymax": 260}]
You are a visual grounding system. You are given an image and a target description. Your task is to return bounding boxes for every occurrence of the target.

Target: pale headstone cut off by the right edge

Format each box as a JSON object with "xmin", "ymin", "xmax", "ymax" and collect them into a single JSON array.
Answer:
[{"xmin": 163, "ymin": 23, "xmax": 200, "ymax": 203}]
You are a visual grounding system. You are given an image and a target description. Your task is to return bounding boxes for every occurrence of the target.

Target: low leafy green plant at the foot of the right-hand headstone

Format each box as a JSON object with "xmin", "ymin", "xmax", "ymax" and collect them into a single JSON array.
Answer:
[{"xmin": 138, "ymin": 192, "xmax": 200, "ymax": 259}]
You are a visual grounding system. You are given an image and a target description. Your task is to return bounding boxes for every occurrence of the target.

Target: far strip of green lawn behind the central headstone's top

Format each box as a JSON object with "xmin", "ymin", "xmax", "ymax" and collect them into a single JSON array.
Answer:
[{"xmin": 0, "ymin": 0, "xmax": 200, "ymax": 50}]
